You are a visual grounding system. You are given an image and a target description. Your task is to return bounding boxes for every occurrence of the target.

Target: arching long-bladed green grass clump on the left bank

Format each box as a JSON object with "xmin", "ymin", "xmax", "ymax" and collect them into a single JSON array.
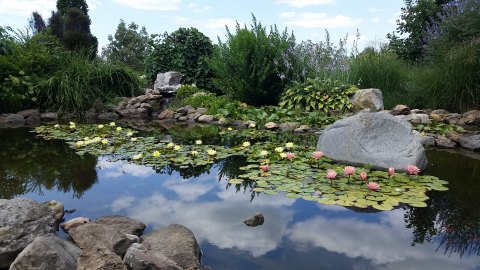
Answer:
[{"xmin": 38, "ymin": 52, "xmax": 142, "ymax": 112}]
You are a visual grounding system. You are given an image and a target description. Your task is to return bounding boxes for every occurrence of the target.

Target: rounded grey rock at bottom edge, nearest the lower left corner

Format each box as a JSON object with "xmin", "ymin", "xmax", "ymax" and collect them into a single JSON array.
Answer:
[{"xmin": 9, "ymin": 234, "xmax": 82, "ymax": 270}]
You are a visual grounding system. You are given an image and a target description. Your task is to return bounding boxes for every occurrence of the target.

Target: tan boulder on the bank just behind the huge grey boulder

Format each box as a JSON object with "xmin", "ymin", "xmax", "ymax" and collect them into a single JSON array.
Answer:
[{"xmin": 350, "ymin": 88, "xmax": 384, "ymax": 112}]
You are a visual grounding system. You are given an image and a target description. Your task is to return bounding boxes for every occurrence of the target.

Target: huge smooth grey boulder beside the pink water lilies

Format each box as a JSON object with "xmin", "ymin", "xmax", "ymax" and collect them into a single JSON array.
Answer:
[{"xmin": 317, "ymin": 112, "xmax": 427, "ymax": 170}]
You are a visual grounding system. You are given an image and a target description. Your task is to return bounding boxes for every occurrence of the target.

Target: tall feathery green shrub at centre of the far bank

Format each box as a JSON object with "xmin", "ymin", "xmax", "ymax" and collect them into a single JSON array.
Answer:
[{"xmin": 210, "ymin": 14, "xmax": 295, "ymax": 106}]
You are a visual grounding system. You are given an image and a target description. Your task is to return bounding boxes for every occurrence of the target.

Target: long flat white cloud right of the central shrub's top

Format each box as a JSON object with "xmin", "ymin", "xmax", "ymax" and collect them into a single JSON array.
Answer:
[{"xmin": 280, "ymin": 12, "xmax": 362, "ymax": 29}]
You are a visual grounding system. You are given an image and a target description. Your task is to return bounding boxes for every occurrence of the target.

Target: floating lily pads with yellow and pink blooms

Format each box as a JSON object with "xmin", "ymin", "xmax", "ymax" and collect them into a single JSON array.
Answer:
[{"xmin": 35, "ymin": 122, "xmax": 447, "ymax": 210}]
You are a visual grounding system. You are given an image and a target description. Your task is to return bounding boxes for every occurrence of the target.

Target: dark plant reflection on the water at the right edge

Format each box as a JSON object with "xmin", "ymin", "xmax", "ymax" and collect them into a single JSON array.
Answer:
[{"xmin": 405, "ymin": 151, "xmax": 480, "ymax": 256}]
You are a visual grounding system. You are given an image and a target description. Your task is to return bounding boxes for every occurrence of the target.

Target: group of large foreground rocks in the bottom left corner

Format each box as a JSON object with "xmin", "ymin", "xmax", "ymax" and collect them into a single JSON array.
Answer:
[{"xmin": 0, "ymin": 198, "xmax": 211, "ymax": 270}]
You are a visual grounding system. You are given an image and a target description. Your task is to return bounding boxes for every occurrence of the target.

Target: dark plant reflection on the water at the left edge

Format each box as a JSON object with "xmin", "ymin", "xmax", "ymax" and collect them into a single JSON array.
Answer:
[{"xmin": 0, "ymin": 128, "xmax": 98, "ymax": 199}]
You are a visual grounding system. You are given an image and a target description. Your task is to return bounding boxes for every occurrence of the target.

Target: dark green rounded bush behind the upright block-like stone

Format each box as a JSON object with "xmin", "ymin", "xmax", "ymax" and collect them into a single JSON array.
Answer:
[{"xmin": 146, "ymin": 27, "xmax": 213, "ymax": 90}]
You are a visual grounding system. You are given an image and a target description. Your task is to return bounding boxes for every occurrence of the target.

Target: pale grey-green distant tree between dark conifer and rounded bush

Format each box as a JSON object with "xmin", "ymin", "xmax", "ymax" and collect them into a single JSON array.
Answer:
[{"xmin": 102, "ymin": 20, "xmax": 150, "ymax": 72}]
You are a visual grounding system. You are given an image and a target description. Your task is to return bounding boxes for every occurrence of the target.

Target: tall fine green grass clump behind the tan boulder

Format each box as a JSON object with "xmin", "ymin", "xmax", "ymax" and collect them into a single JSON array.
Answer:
[{"xmin": 349, "ymin": 48, "xmax": 409, "ymax": 108}]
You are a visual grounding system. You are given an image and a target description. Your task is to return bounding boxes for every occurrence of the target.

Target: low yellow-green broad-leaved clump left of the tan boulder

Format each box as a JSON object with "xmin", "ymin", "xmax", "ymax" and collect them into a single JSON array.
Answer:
[{"xmin": 279, "ymin": 78, "xmax": 357, "ymax": 113}]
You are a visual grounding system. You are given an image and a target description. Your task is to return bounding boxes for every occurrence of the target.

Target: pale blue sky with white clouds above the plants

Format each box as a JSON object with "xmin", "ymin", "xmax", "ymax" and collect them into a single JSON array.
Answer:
[{"xmin": 0, "ymin": 0, "xmax": 404, "ymax": 50}]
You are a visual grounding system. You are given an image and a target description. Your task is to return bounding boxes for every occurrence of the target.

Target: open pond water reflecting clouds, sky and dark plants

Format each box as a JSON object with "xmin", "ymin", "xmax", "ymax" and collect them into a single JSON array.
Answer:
[{"xmin": 0, "ymin": 128, "xmax": 480, "ymax": 270}]
